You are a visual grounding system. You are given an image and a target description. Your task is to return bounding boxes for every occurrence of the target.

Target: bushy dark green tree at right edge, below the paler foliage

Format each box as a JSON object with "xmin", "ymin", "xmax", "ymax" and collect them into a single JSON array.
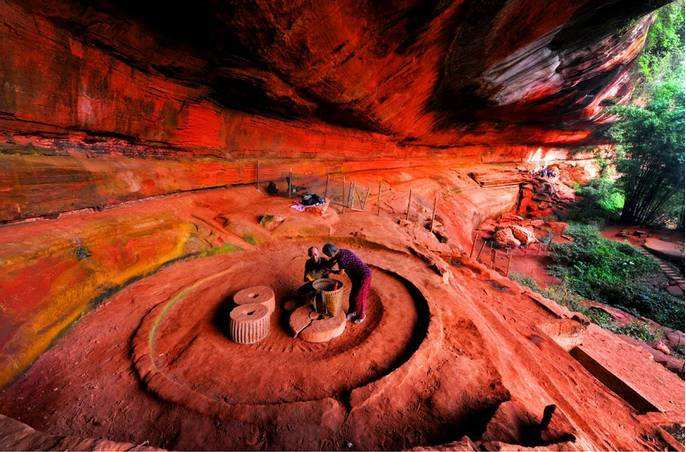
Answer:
[{"xmin": 610, "ymin": 81, "xmax": 684, "ymax": 225}]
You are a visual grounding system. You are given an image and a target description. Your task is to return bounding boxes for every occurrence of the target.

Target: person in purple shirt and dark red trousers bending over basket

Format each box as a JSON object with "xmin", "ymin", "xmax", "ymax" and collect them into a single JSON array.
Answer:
[{"xmin": 323, "ymin": 243, "xmax": 372, "ymax": 323}]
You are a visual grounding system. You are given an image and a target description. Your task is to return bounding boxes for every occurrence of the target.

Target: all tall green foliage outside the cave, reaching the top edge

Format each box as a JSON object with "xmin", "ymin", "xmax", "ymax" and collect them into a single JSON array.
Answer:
[{"xmin": 609, "ymin": 0, "xmax": 684, "ymax": 228}]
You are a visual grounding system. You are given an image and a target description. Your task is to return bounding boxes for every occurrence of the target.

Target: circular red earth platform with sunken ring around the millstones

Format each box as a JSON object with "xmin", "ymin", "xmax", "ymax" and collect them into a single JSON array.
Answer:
[{"xmin": 134, "ymin": 240, "xmax": 428, "ymax": 411}]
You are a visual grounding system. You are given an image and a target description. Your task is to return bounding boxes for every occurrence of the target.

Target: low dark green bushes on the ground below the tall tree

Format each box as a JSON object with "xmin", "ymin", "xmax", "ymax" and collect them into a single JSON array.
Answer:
[{"xmin": 550, "ymin": 224, "xmax": 684, "ymax": 330}]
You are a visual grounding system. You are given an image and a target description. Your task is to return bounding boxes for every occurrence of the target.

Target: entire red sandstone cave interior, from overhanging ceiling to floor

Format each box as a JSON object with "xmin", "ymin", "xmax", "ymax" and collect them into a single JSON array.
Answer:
[{"xmin": 0, "ymin": 0, "xmax": 684, "ymax": 449}]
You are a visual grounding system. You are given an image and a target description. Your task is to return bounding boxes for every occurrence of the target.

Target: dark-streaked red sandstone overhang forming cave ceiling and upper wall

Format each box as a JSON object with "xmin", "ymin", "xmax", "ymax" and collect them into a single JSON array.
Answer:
[{"xmin": 0, "ymin": 0, "xmax": 664, "ymax": 221}]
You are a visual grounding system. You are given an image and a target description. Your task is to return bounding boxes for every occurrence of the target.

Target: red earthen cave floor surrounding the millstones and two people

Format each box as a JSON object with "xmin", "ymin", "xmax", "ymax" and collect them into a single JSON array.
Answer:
[{"xmin": 0, "ymin": 176, "xmax": 683, "ymax": 449}]
